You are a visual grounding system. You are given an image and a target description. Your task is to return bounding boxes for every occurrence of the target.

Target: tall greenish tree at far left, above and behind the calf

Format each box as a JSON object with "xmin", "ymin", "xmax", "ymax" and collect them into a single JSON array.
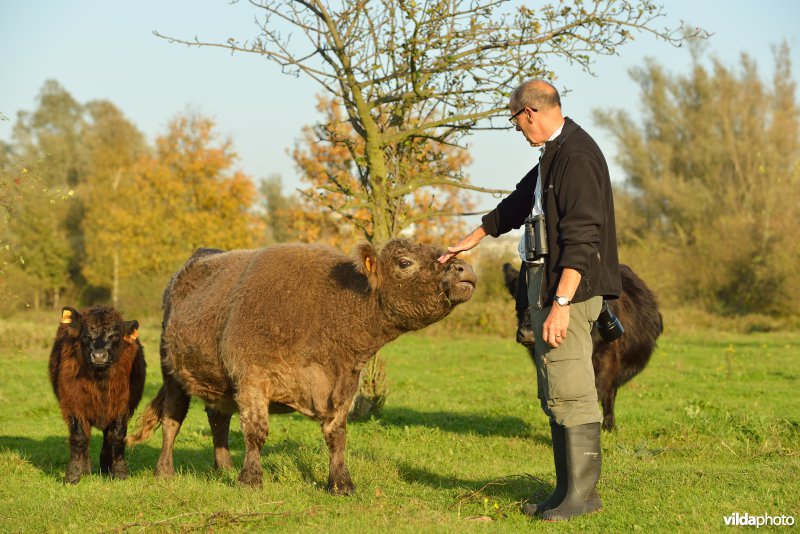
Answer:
[{"xmin": 10, "ymin": 80, "xmax": 87, "ymax": 308}]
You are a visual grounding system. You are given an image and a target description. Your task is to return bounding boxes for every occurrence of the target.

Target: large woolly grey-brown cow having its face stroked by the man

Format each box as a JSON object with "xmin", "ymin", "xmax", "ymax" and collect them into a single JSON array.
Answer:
[{"xmin": 128, "ymin": 241, "xmax": 476, "ymax": 494}]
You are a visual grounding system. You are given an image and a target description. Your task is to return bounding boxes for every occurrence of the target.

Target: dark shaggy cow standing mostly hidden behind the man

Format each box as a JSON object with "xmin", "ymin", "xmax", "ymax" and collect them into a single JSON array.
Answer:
[{"xmin": 503, "ymin": 263, "xmax": 664, "ymax": 431}]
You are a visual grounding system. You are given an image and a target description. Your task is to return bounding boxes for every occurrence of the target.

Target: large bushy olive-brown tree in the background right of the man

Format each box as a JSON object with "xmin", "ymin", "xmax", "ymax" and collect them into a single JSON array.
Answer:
[{"xmin": 597, "ymin": 45, "xmax": 800, "ymax": 315}]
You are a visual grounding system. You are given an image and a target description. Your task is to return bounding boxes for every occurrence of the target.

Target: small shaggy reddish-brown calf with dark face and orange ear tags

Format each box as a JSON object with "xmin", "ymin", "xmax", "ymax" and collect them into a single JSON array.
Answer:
[{"xmin": 49, "ymin": 306, "xmax": 145, "ymax": 484}]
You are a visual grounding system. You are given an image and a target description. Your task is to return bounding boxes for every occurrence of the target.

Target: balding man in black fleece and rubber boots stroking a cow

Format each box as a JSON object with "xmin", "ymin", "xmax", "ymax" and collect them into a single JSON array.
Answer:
[{"xmin": 439, "ymin": 80, "xmax": 621, "ymax": 521}]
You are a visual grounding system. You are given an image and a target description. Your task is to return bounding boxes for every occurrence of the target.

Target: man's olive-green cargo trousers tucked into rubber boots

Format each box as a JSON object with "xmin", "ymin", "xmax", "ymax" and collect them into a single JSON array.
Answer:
[{"xmin": 528, "ymin": 267, "xmax": 603, "ymax": 427}]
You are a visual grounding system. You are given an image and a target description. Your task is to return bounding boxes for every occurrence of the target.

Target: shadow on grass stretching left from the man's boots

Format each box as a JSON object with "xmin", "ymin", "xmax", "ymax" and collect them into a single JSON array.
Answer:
[{"xmin": 398, "ymin": 462, "xmax": 555, "ymax": 504}]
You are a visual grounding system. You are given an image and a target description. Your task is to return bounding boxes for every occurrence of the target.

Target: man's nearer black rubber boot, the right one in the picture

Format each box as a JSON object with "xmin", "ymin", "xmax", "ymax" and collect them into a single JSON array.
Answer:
[{"xmin": 542, "ymin": 423, "xmax": 603, "ymax": 521}]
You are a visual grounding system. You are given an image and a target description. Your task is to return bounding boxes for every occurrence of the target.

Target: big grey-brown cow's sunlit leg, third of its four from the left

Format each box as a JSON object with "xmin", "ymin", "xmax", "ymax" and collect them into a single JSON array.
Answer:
[{"xmin": 236, "ymin": 381, "xmax": 269, "ymax": 486}]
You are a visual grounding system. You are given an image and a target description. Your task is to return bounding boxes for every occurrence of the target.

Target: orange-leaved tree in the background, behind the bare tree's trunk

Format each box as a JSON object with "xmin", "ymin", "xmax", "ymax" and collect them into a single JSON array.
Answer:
[{"xmin": 292, "ymin": 97, "xmax": 474, "ymax": 248}]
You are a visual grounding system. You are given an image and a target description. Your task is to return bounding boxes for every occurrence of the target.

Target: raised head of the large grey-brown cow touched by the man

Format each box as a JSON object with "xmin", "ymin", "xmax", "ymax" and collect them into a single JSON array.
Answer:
[{"xmin": 356, "ymin": 240, "xmax": 477, "ymax": 330}]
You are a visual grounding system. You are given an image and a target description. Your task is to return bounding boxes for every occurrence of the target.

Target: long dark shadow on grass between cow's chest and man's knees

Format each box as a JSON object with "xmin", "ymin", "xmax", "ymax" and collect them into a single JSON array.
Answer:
[{"xmin": 380, "ymin": 407, "xmax": 550, "ymax": 445}]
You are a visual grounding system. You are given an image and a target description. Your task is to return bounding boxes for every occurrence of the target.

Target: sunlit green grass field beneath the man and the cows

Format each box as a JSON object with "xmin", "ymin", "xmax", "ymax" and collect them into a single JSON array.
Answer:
[{"xmin": 0, "ymin": 318, "xmax": 800, "ymax": 532}]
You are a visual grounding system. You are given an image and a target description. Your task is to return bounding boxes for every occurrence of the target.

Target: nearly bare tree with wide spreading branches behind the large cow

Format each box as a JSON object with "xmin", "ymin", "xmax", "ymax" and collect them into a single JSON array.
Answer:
[{"xmin": 156, "ymin": 0, "xmax": 708, "ymax": 242}]
